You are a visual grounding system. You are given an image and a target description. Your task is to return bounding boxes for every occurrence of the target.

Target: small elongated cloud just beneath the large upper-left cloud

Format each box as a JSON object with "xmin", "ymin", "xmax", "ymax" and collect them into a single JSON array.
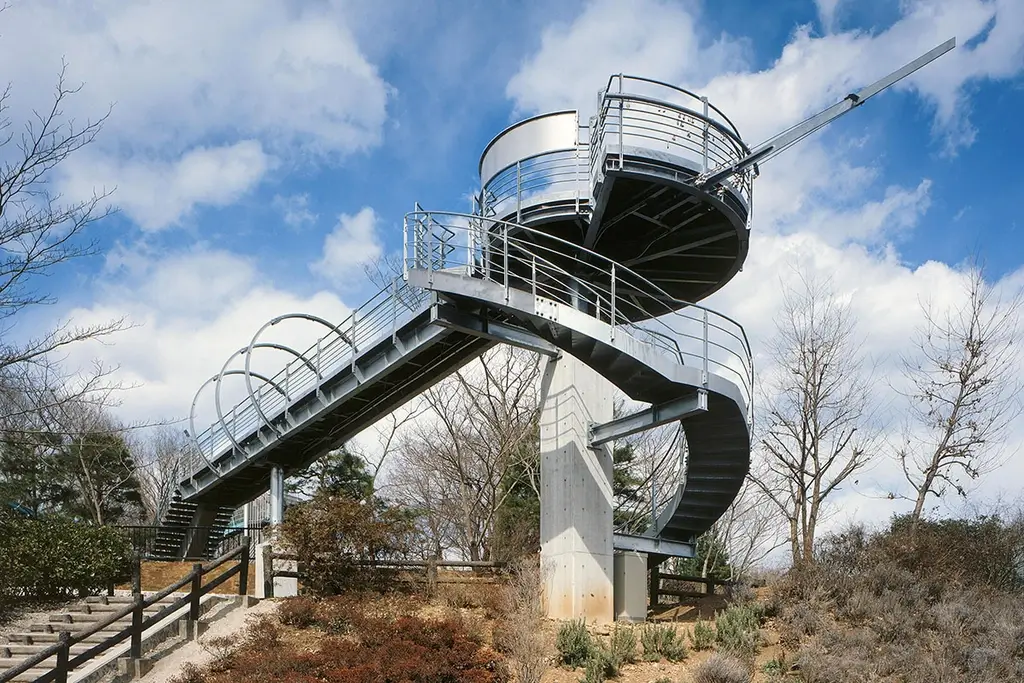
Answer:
[{"xmin": 60, "ymin": 140, "xmax": 273, "ymax": 230}]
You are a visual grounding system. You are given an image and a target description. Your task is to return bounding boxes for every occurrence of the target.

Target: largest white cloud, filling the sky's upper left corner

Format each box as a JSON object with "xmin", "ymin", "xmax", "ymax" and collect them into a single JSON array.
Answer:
[{"xmin": 0, "ymin": 0, "xmax": 391, "ymax": 227}]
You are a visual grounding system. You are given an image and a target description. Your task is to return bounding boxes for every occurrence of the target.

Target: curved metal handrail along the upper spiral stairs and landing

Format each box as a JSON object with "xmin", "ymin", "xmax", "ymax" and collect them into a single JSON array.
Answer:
[{"xmin": 404, "ymin": 211, "xmax": 754, "ymax": 420}]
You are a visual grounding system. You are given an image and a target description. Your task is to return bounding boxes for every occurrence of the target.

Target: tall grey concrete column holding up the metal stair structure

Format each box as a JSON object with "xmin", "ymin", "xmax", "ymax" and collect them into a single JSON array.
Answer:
[{"xmin": 541, "ymin": 354, "xmax": 614, "ymax": 623}]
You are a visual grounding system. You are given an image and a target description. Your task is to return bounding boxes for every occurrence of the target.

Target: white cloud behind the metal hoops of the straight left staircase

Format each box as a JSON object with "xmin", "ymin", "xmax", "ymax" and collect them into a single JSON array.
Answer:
[{"xmin": 70, "ymin": 246, "xmax": 349, "ymax": 429}]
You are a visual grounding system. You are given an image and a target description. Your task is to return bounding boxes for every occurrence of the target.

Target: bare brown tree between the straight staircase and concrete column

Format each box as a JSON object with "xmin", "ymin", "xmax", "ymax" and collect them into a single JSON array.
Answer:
[{"xmin": 395, "ymin": 346, "xmax": 539, "ymax": 560}]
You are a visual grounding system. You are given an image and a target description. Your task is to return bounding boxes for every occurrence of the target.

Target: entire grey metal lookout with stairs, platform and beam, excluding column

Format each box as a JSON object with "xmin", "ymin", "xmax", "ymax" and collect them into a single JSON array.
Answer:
[{"xmin": 179, "ymin": 42, "xmax": 952, "ymax": 554}]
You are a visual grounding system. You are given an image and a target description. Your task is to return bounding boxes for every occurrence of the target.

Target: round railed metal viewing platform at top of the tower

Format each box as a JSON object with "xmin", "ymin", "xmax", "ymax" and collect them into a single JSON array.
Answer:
[{"xmin": 476, "ymin": 76, "xmax": 757, "ymax": 305}]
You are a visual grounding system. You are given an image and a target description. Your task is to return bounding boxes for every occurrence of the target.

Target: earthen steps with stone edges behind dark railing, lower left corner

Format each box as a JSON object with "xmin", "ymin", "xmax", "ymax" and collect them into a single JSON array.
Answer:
[{"xmin": 0, "ymin": 593, "xmax": 238, "ymax": 681}]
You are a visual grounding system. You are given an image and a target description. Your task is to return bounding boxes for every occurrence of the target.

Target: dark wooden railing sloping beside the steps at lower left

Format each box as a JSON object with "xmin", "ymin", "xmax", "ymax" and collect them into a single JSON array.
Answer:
[{"xmin": 0, "ymin": 537, "xmax": 249, "ymax": 683}]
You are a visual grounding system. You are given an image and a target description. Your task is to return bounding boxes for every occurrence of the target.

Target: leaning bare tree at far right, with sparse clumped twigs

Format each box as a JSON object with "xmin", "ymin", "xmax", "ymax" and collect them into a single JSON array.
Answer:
[{"xmin": 896, "ymin": 264, "xmax": 1024, "ymax": 524}]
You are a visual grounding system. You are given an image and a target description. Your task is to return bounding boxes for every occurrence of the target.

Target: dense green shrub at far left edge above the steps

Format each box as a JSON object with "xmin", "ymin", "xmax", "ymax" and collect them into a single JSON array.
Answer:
[{"xmin": 0, "ymin": 511, "xmax": 133, "ymax": 602}]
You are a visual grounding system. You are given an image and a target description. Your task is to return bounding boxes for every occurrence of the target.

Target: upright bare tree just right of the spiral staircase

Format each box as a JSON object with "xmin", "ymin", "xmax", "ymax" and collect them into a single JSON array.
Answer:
[{"xmin": 753, "ymin": 273, "xmax": 872, "ymax": 564}]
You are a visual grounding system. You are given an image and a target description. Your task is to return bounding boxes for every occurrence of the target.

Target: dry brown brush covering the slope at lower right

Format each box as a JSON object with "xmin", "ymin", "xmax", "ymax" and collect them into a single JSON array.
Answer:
[{"xmin": 773, "ymin": 518, "xmax": 1024, "ymax": 683}]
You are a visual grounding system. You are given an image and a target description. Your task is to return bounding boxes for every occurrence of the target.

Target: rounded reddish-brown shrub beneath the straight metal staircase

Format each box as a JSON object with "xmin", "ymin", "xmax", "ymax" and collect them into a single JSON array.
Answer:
[{"xmin": 282, "ymin": 494, "xmax": 413, "ymax": 596}]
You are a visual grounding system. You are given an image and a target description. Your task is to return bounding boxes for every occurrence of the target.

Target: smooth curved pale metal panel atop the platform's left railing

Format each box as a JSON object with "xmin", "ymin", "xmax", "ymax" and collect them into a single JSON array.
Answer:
[{"xmin": 480, "ymin": 111, "xmax": 580, "ymax": 185}]
